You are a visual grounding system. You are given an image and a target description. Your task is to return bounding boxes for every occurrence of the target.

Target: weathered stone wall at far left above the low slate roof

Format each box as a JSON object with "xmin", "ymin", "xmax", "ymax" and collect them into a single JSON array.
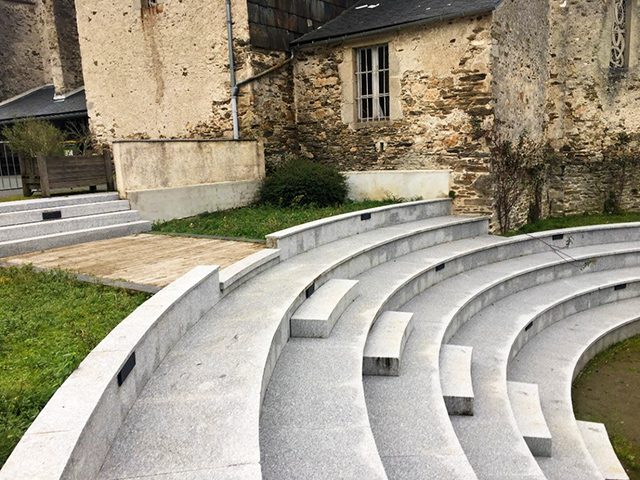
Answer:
[{"xmin": 0, "ymin": 2, "xmax": 51, "ymax": 102}]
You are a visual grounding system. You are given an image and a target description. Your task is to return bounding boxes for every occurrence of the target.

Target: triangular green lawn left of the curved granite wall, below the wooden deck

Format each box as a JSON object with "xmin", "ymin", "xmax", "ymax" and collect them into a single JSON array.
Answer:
[{"xmin": 0, "ymin": 267, "xmax": 149, "ymax": 466}]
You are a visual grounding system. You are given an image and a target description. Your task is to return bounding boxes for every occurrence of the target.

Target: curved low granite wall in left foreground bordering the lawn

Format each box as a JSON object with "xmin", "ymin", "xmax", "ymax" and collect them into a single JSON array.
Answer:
[{"xmin": 0, "ymin": 266, "xmax": 221, "ymax": 480}]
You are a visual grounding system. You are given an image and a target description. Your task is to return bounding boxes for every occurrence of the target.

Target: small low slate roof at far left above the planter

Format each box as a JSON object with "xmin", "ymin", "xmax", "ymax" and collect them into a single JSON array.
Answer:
[{"xmin": 0, "ymin": 85, "xmax": 87, "ymax": 124}]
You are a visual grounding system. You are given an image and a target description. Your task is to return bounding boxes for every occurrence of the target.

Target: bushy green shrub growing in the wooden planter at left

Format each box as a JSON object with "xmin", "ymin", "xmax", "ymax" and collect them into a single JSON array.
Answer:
[{"xmin": 2, "ymin": 118, "xmax": 66, "ymax": 157}]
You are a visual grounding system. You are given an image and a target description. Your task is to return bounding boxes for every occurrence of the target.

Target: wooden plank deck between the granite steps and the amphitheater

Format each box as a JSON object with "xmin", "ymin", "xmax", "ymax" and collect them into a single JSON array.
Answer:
[{"xmin": 4, "ymin": 233, "xmax": 265, "ymax": 287}]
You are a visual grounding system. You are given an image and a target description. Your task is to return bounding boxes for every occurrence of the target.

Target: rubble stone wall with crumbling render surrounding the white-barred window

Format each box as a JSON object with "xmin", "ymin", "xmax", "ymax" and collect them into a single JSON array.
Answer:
[{"xmin": 295, "ymin": 15, "xmax": 493, "ymax": 214}]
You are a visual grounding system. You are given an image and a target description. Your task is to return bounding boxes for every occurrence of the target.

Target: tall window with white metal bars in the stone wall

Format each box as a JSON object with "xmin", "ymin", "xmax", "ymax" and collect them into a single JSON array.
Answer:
[{"xmin": 356, "ymin": 45, "xmax": 390, "ymax": 122}]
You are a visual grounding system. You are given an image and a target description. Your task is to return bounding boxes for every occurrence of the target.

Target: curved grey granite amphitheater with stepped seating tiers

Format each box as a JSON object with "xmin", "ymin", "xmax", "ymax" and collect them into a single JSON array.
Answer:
[{"xmin": 0, "ymin": 199, "xmax": 640, "ymax": 480}]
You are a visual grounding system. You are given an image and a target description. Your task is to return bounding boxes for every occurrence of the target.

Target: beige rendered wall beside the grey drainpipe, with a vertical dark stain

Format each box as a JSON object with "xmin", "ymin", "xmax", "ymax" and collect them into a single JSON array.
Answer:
[{"xmin": 76, "ymin": 0, "xmax": 250, "ymax": 141}]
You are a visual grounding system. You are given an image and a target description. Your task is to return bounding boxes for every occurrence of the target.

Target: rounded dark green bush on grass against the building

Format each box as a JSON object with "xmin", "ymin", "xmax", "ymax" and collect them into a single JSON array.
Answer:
[{"xmin": 260, "ymin": 159, "xmax": 349, "ymax": 207}]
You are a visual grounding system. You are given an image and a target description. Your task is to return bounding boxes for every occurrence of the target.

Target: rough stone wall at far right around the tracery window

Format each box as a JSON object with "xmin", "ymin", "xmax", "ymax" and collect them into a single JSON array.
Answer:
[{"xmin": 546, "ymin": 0, "xmax": 640, "ymax": 214}]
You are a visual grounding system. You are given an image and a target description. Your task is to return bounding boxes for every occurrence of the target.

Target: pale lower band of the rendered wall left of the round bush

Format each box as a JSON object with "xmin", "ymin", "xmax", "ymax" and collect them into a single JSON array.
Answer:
[{"xmin": 127, "ymin": 180, "xmax": 261, "ymax": 222}]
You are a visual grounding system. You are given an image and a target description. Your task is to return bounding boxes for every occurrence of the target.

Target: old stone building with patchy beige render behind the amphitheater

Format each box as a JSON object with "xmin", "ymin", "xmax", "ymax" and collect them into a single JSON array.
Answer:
[{"xmin": 0, "ymin": 0, "xmax": 640, "ymax": 225}]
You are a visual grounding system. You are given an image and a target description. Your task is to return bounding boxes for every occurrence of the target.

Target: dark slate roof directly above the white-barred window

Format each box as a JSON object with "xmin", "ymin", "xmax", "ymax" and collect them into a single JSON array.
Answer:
[{"xmin": 291, "ymin": 0, "xmax": 502, "ymax": 45}]
